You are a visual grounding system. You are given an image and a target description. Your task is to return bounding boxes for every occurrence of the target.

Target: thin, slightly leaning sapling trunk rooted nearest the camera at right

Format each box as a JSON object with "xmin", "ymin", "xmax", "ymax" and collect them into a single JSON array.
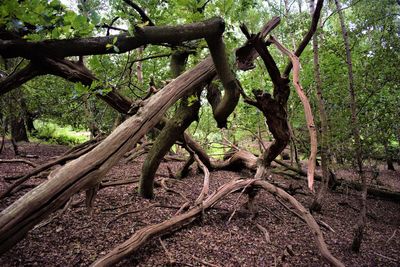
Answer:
[{"xmin": 335, "ymin": 0, "xmax": 367, "ymax": 252}]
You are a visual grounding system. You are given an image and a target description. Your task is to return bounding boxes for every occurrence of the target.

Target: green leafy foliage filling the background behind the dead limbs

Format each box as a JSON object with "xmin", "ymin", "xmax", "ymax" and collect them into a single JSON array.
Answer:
[{"xmin": 0, "ymin": 0, "xmax": 400, "ymax": 163}]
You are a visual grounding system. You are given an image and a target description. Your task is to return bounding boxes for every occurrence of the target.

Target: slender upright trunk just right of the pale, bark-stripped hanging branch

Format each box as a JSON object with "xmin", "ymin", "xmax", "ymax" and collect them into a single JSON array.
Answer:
[{"xmin": 310, "ymin": 0, "xmax": 330, "ymax": 212}]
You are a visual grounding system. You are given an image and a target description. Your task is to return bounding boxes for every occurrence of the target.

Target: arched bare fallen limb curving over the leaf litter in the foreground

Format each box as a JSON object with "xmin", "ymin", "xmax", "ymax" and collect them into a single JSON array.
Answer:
[{"xmin": 92, "ymin": 179, "xmax": 344, "ymax": 266}]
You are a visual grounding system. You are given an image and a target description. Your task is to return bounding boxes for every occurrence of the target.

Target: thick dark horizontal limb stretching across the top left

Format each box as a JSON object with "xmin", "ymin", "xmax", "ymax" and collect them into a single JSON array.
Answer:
[{"xmin": 0, "ymin": 18, "xmax": 224, "ymax": 59}]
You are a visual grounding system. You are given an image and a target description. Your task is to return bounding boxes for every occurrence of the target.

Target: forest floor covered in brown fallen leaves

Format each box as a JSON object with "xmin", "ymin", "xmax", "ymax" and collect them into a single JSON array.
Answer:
[{"xmin": 0, "ymin": 143, "xmax": 400, "ymax": 266}]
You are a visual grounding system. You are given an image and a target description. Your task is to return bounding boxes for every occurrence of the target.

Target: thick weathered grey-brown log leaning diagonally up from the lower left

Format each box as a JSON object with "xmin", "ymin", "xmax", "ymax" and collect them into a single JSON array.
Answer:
[{"xmin": 0, "ymin": 58, "xmax": 215, "ymax": 254}]
